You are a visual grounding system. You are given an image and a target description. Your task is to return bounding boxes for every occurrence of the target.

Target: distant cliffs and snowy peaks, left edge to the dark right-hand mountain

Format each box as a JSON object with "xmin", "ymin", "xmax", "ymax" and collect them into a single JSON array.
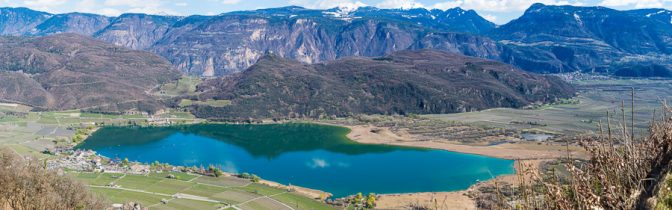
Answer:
[{"xmin": 0, "ymin": 7, "xmax": 498, "ymax": 76}]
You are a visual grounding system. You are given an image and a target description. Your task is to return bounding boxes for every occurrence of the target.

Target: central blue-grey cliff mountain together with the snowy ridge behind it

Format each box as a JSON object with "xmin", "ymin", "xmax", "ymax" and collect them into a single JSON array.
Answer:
[{"xmin": 150, "ymin": 7, "xmax": 498, "ymax": 76}]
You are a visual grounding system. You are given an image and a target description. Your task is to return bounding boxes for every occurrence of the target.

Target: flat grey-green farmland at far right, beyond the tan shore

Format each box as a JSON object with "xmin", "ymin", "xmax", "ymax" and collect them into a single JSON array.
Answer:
[{"xmin": 426, "ymin": 79, "xmax": 672, "ymax": 134}]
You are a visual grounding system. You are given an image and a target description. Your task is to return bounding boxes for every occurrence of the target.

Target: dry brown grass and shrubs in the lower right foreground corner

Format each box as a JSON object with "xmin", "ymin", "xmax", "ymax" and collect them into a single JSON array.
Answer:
[{"xmin": 510, "ymin": 101, "xmax": 672, "ymax": 209}]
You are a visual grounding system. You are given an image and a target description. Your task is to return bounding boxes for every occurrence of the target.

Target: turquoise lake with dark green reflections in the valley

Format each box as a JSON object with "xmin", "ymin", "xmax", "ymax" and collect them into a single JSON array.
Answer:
[{"xmin": 78, "ymin": 123, "xmax": 514, "ymax": 197}]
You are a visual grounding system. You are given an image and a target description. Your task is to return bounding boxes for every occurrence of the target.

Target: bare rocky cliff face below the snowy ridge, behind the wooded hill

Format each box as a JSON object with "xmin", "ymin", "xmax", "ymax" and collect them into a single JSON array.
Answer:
[{"xmin": 151, "ymin": 15, "xmax": 498, "ymax": 76}]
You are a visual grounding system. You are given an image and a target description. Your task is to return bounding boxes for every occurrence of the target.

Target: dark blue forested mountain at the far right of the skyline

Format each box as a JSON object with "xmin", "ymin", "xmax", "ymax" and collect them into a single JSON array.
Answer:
[{"xmin": 488, "ymin": 3, "xmax": 672, "ymax": 76}]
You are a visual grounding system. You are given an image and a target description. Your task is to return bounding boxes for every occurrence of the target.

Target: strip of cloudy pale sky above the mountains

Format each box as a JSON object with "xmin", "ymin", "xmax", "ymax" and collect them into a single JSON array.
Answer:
[{"xmin": 0, "ymin": 0, "xmax": 672, "ymax": 24}]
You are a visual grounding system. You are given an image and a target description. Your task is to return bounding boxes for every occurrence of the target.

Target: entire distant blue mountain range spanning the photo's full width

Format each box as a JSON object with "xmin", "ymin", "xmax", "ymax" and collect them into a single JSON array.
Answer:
[{"xmin": 0, "ymin": 3, "xmax": 672, "ymax": 77}]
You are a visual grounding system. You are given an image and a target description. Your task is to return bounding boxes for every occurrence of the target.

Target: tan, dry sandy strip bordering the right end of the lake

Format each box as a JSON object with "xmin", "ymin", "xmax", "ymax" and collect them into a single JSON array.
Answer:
[{"xmin": 338, "ymin": 126, "xmax": 586, "ymax": 210}]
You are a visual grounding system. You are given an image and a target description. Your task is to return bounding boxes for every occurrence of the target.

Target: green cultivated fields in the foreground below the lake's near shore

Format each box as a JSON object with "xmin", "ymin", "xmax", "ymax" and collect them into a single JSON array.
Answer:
[{"xmin": 72, "ymin": 172, "xmax": 332, "ymax": 210}]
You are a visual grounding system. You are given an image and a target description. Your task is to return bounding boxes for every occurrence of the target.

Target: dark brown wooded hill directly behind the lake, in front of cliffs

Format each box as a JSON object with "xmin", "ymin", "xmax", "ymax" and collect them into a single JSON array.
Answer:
[{"xmin": 192, "ymin": 50, "xmax": 575, "ymax": 121}]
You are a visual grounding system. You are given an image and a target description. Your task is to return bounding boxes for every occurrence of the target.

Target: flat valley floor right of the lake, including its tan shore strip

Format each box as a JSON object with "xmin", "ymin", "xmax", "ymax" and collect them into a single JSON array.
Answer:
[{"xmin": 321, "ymin": 79, "xmax": 672, "ymax": 209}]
